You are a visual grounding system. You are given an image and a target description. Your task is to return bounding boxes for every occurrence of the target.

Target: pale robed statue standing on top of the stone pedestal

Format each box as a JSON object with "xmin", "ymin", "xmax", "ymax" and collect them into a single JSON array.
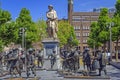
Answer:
[{"xmin": 46, "ymin": 5, "xmax": 58, "ymax": 39}]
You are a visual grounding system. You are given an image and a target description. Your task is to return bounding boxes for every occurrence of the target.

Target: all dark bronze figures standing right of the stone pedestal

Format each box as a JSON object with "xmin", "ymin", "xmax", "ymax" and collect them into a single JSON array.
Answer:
[{"xmin": 60, "ymin": 48, "xmax": 109, "ymax": 76}]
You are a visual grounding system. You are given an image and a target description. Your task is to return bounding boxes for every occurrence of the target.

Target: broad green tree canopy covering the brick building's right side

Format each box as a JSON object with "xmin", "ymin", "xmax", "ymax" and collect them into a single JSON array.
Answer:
[{"xmin": 88, "ymin": 8, "xmax": 111, "ymax": 48}]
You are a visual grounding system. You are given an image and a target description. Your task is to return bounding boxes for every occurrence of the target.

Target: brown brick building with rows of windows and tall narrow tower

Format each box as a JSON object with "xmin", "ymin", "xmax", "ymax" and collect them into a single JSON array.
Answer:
[{"xmin": 68, "ymin": 0, "xmax": 114, "ymax": 51}]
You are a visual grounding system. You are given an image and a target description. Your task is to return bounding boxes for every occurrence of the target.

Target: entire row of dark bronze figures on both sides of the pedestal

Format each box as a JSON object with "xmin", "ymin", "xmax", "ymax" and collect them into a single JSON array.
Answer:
[{"xmin": 0, "ymin": 48, "xmax": 107, "ymax": 77}]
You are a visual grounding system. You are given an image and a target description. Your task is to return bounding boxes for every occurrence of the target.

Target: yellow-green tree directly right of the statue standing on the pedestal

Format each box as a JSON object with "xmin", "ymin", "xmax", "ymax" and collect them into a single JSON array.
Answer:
[{"xmin": 57, "ymin": 21, "xmax": 78, "ymax": 47}]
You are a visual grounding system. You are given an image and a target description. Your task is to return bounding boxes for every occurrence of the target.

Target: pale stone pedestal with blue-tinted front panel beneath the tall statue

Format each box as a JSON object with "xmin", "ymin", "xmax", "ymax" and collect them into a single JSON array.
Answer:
[{"xmin": 42, "ymin": 38, "xmax": 60, "ymax": 69}]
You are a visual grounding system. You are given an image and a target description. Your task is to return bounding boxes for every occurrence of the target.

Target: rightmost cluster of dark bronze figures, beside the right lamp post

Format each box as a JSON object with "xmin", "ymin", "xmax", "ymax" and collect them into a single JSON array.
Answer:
[{"xmin": 83, "ymin": 48, "xmax": 108, "ymax": 76}]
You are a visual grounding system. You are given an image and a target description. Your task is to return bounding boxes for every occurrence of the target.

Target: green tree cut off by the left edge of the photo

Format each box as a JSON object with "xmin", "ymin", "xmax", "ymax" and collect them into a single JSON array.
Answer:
[{"xmin": 0, "ymin": 9, "xmax": 15, "ymax": 51}]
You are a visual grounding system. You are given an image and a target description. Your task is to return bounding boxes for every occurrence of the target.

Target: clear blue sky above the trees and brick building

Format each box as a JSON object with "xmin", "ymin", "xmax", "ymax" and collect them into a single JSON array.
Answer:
[{"xmin": 0, "ymin": 0, "xmax": 116, "ymax": 21}]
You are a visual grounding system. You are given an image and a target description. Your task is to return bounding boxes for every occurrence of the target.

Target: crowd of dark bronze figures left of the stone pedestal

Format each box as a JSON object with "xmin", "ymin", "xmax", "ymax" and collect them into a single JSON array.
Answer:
[{"xmin": 0, "ymin": 48, "xmax": 42, "ymax": 77}]
